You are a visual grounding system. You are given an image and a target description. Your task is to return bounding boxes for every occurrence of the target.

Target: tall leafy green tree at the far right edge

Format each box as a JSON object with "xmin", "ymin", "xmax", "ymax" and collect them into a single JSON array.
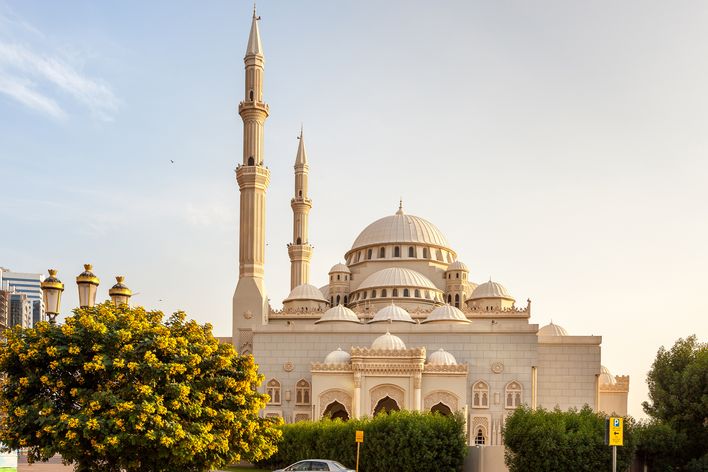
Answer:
[{"xmin": 641, "ymin": 335, "xmax": 708, "ymax": 470}]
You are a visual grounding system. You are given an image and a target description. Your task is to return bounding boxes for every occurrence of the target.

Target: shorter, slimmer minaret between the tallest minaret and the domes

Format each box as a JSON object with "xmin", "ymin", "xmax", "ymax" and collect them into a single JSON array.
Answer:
[{"xmin": 288, "ymin": 128, "xmax": 312, "ymax": 290}]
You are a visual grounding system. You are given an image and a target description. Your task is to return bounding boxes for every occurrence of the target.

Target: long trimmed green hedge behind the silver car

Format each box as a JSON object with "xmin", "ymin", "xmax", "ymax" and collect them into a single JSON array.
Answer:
[{"xmin": 253, "ymin": 411, "xmax": 467, "ymax": 472}]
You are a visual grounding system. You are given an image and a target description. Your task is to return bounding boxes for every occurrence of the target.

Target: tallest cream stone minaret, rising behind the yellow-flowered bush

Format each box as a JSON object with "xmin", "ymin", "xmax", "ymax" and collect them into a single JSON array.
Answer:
[{"xmin": 233, "ymin": 7, "xmax": 270, "ymax": 346}]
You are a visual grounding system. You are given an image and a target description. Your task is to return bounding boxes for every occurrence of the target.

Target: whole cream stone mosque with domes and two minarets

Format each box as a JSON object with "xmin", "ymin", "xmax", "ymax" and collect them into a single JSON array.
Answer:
[{"xmin": 232, "ymin": 12, "xmax": 629, "ymax": 446}]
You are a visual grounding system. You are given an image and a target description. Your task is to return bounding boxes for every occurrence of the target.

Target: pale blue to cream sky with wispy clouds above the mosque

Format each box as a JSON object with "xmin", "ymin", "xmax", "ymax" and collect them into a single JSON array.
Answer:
[{"xmin": 0, "ymin": 0, "xmax": 708, "ymax": 416}]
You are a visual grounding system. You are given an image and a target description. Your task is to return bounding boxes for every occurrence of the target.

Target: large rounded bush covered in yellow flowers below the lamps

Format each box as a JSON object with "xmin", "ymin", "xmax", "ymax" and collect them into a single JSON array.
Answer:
[{"xmin": 0, "ymin": 303, "xmax": 281, "ymax": 472}]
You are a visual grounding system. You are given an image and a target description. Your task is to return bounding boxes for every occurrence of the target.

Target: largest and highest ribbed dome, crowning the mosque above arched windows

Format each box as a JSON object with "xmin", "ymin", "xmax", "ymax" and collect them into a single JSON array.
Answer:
[{"xmin": 352, "ymin": 209, "xmax": 448, "ymax": 249}]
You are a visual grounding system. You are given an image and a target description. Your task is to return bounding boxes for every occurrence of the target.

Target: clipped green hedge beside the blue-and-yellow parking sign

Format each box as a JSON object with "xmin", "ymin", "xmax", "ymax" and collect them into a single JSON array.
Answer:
[{"xmin": 504, "ymin": 405, "xmax": 634, "ymax": 472}]
